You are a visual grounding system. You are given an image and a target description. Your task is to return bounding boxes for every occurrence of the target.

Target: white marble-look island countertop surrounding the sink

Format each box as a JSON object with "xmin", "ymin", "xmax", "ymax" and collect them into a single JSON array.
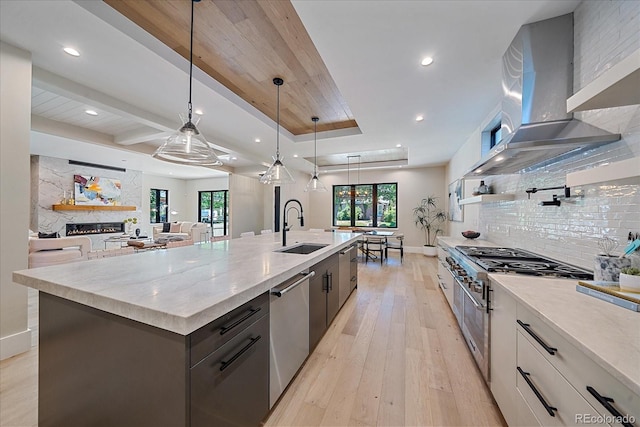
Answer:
[{"xmin": 13, "ymin": 231, "xmax": 359, "ymax": 335}]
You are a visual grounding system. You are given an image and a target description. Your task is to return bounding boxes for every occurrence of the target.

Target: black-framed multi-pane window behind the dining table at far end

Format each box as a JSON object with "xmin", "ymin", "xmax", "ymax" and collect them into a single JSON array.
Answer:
[{"xmin": 333, "ymin": 183, "xmax": 398, "ymax": 228}]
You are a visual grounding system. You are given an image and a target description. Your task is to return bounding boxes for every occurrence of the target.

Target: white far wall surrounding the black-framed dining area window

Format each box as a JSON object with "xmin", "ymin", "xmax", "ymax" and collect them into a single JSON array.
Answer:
[{"xmin": 305, "ymin": 166, "xmax": 448, "ymax": 248}]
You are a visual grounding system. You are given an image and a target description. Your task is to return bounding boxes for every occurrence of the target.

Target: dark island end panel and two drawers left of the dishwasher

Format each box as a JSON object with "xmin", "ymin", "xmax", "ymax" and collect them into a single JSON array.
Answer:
[{"xmin": 38, "ymin": 292, "xmax": 269, "ymax": 427}]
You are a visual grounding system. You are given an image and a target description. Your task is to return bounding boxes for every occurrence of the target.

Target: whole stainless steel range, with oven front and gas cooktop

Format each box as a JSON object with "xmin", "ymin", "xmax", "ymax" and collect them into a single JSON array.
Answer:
[{"xmin": 447, "ymin": 246, "xmax": 593, "ymax": 381}]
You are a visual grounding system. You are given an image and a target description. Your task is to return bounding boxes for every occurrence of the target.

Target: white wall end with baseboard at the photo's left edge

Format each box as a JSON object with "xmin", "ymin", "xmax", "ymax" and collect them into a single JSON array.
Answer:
[{"xmin": 0, "ymin": 42, "xmax": 31, "ymax": 359}]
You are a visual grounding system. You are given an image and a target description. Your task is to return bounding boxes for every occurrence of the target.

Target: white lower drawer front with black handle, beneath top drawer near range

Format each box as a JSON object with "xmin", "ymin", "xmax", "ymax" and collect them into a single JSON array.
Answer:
[{"xmin": 516, "ymin": 331, "xmax": 606, "ymax": 426}]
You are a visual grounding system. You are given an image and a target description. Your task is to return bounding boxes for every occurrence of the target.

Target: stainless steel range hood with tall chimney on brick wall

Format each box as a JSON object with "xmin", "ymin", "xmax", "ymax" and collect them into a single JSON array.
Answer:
[{"xmin": 465, "ymin": 14, "xmax": 620, "ymax": 177}]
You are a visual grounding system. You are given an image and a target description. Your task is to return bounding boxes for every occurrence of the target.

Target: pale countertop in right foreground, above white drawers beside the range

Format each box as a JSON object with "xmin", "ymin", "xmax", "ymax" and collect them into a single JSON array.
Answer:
[{"xmin": 489, "ymin": 274, "xmax": 640, "ymax": 395}]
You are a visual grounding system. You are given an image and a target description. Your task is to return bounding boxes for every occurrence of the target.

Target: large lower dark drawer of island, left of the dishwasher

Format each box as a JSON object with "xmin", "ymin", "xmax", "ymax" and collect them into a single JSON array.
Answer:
[{"xmin": 190, "ymin": 316, "xmax": 269, "ymax": 427}]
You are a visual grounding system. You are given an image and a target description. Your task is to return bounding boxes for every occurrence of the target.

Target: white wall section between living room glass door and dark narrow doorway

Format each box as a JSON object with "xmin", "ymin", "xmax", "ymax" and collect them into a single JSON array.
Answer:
[{"xmin": 229, "ymin": 174, "xmax": 264, "ymax": 238}]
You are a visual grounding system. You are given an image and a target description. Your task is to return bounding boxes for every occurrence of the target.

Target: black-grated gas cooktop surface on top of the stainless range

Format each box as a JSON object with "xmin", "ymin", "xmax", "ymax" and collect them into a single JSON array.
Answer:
[{"xmin": 456, "ymin": 246, "xmax": 593, "ymax": 280}]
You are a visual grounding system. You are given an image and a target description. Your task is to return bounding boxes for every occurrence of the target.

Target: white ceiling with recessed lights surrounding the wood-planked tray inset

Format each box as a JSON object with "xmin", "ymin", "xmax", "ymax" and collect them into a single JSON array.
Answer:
[{"xmin": 0, "ymin": 0, "xmax": 579, "ymax": 178}]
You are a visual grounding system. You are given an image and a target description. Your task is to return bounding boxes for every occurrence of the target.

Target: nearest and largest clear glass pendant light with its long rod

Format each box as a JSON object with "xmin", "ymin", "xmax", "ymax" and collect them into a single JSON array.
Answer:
[{"xmin": 152, "ymin": 0, "xmax": 222, "ymax": 166}]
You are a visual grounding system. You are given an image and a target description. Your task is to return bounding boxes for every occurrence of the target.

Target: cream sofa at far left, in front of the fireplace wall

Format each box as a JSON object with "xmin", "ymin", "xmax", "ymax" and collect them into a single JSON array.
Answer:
[{"xmin": 29, "ymin": 236, "xmax": 91, "ymax": 268}]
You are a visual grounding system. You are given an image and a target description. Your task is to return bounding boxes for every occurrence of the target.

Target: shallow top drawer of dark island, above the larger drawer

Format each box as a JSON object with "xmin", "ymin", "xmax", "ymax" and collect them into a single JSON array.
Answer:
[{"xmin": 190, "ymin": 292, "xmax": 269, "ymax": 366}]
